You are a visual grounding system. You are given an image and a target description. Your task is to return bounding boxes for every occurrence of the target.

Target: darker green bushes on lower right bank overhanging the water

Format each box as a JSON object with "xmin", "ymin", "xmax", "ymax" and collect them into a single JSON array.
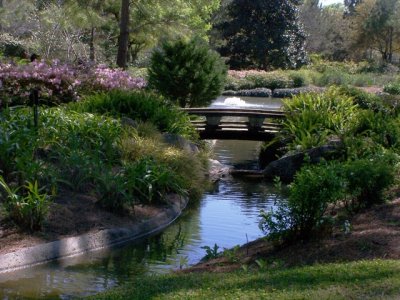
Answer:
[{"xmin": 260, "ymin": 155, "xmax": 396, "ymax": 242}]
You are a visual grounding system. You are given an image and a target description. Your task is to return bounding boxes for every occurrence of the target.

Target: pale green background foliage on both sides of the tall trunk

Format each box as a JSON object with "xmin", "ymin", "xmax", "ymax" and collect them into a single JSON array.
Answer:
[{"xmin": 0, "ymin": 0, "xmax": 220, "ymax": 63}]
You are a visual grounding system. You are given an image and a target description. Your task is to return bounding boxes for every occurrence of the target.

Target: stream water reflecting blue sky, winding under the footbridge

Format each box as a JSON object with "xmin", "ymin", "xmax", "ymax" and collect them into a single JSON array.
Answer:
[{"xmin": 0, "ymin": 97, "xmax": 279, "ymax": 299}]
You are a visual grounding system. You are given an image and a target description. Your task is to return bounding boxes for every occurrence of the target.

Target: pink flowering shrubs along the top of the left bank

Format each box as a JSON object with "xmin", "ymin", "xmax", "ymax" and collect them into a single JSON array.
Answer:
[{"xmin": 0, "ymin": 60, "xmax": 146, "ymax": 108}]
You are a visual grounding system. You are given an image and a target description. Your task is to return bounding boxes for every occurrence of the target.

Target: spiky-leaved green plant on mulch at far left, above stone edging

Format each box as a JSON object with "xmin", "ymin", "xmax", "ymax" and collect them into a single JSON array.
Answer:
[{"xmin": 0, "ymin": 176, "xmax": 51, "ymax": 231}]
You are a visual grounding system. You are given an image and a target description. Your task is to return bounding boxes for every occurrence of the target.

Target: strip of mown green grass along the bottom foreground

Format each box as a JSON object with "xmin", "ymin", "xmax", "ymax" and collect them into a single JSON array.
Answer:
[{"xmin": 93, "ymin": 260, "xmax": 400, "ymax": 299}]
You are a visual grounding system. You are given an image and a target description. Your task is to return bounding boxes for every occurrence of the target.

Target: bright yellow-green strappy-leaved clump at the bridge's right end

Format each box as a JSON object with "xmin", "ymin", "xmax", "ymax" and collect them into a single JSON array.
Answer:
[{"xmin": 280, "ymin": 87, "xmax": 358, "ymax": 150}]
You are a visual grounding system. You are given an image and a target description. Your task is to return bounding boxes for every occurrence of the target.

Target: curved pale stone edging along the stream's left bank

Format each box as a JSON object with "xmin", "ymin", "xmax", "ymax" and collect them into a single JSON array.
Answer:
[{"xmin": 0, "ymin": 197, "xmax": 188, "ymax": 273}]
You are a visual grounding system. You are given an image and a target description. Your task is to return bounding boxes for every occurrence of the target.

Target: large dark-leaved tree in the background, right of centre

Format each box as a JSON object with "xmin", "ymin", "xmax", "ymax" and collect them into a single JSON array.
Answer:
[{"xmin": 217, "ymin": 0, "xmax": 307, "ymax": 69}]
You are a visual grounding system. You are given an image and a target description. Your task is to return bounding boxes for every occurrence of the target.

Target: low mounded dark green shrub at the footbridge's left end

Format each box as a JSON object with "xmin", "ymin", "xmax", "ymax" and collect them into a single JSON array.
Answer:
[{"xmin": 72, "ymin": 91, "xmax": 197, "ymax": 139}]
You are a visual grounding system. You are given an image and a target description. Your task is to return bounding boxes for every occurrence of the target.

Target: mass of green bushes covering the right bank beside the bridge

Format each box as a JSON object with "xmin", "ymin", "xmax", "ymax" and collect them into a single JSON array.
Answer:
[{"xmin": 261, "ymin": 86, "xmax": 400, "ymax": 241}]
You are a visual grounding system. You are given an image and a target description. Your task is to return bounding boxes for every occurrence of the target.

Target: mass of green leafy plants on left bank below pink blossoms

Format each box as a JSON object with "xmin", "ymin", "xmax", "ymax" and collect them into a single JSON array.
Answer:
[{"xmin": 0, "ymin": 98, "xmax": 204, "ymax": 230}]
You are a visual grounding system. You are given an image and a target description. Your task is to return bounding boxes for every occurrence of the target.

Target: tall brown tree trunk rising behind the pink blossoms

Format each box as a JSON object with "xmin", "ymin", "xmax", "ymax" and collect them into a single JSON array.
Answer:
[{"xmin": 117, "ymin": 0, "xmax": 129, "ymax": 69}]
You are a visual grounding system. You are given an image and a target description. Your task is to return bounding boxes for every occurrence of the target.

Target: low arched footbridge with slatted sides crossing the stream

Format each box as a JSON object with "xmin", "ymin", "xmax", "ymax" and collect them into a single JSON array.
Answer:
[{"xmin": 183, "ymin": 108, "xmax": 285, "ymax": 141}]
